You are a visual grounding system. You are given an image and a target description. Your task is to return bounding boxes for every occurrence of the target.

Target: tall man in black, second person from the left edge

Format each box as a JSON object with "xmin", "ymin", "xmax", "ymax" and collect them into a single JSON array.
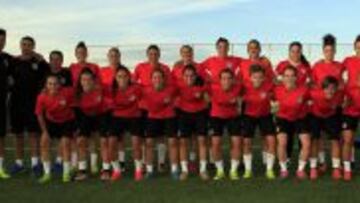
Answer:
[{"xmin": 10, "ymin": 37, "xmax": 50, "ymax": 175}]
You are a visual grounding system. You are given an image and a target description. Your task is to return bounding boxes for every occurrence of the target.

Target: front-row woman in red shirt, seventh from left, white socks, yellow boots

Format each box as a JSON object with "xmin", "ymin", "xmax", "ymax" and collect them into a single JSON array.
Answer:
[{"xmin": 242, "ymin": 64, "xmax": 276, "ymax": 179}]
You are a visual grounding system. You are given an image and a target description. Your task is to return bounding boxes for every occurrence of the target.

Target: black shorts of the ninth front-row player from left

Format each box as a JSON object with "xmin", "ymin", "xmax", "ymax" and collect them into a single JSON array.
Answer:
[{"xmin": 309, "ymin": 114, "xmax": 341, "ymax": 140}]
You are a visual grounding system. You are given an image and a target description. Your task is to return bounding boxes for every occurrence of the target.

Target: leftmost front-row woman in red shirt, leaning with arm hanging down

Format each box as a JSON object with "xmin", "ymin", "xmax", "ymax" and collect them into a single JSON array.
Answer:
[{"xmin": 35, "ymin": 74, "xmax": 75, "ymax": 183}]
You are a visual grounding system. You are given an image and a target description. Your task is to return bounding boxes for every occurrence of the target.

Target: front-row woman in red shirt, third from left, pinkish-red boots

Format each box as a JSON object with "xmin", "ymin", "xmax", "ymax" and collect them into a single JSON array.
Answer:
[{"xmin": 110, "ymin": 66, "xmax": 144, "ymax": 181}]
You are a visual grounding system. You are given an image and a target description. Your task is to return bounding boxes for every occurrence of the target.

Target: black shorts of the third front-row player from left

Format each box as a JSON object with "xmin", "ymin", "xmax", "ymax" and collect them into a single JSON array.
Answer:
[{"xmin": 110, "ymin": 117, "xmax": 144, "ymax": 137}]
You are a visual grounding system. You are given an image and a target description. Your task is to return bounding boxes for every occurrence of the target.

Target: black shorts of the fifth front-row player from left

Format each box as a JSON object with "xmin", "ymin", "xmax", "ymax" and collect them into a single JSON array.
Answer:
[{"xmin": 177, "ymin": 110, "xmax": 208, "ymax": 138}]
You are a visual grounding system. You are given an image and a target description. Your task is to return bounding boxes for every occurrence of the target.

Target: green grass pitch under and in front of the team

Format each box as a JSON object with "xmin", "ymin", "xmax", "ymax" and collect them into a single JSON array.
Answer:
[{"xmin": 0, "ymin": 135, "xmax": 360, "ymax": 203}]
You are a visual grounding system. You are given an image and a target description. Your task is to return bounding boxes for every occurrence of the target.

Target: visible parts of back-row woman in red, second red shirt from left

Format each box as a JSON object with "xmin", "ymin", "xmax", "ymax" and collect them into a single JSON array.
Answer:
[{"xmin": 100, "ymin": 47, "xmax": 127, "ymax": 171}]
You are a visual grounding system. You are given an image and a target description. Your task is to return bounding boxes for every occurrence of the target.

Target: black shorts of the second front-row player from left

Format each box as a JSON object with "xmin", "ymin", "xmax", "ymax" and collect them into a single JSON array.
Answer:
[{"xmin": 76, "ymin": 112, "xmax": 111, "ymax": 137}]
